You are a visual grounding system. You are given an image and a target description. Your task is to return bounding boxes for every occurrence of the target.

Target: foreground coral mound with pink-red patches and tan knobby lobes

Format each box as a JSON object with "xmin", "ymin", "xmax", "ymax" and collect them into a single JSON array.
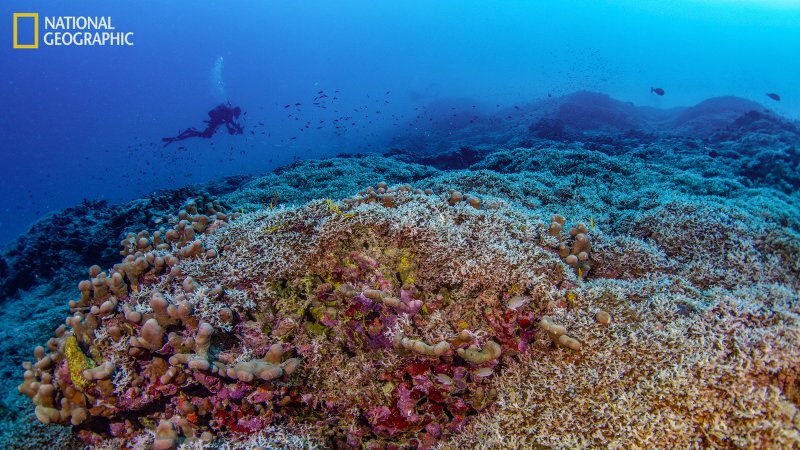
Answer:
[{"xmin": 19, "ymin": 183, "xmax": 592, "ymax": 449}]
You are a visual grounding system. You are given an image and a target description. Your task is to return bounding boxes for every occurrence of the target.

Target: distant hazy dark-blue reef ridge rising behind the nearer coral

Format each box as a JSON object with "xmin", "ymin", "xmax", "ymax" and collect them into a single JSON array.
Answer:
[{"xmin": 388, "ymin": 92, "xmax": 800, "ymax": 193}]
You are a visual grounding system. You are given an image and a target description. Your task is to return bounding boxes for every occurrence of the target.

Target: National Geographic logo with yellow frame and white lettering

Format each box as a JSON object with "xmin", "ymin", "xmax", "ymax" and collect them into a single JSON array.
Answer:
[{"xmin": 14, "ymin": 13, "xmax": 133, "ymax": 49}]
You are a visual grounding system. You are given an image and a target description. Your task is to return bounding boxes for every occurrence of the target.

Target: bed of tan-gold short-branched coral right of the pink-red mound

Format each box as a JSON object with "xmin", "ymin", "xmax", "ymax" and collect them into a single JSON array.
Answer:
[{"xmin": 442, "ymin": 277, "xmax": 800, "ymax": 448}]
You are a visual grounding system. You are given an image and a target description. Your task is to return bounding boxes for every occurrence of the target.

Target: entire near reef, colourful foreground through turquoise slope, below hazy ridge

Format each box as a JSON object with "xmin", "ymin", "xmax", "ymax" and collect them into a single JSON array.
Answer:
[{"xmin": 0, "ymin": 112, "xmax": 800, "ymax": 449}]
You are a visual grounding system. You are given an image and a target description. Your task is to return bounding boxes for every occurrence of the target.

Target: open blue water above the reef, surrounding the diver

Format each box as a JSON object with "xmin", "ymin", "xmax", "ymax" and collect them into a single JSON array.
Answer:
[{"xmin": 0, "ymin": 0, "xmax": 800, "ymax": 245}]
